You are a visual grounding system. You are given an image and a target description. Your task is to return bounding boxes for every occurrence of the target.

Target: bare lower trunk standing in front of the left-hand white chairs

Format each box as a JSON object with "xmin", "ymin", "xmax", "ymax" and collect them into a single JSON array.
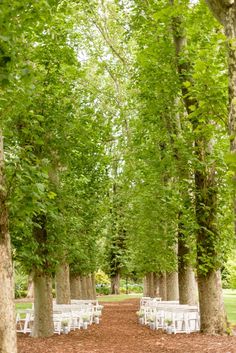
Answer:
[{"xmin": 32, "ymin": 271, "xmax": 54, "ymax": 337}]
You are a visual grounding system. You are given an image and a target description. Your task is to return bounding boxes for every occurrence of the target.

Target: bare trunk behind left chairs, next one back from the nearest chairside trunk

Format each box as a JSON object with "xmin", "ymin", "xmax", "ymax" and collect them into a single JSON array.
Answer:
[{"xmin": 56, "ymin": 263, "xmax": 70, "ymax": 304}]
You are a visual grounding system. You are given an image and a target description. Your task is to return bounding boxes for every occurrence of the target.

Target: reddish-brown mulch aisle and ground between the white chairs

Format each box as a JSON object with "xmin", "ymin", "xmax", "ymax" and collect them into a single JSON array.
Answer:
[{"xmin": 18, "ymin": 299, "xmax": 236, "ymax": 353}]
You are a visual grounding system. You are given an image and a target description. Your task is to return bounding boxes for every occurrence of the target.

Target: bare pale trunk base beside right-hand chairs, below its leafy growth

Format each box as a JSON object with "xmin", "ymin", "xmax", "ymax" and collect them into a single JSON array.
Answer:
[{"xmin": 198, "ymin": 271, "xmax": 226, "ymax": 335}]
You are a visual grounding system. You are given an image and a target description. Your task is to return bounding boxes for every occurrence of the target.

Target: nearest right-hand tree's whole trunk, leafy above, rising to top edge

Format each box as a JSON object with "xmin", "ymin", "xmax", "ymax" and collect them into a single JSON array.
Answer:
[{"xmin": 172, "ymin": 1, "xmax": 230, "ymax": 334}]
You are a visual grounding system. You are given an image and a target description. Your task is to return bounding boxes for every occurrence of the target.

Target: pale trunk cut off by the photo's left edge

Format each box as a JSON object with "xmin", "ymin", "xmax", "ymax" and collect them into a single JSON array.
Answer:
[{"xmin": 0, "ymin": 131, "xmax": 17, "ymax": 353}]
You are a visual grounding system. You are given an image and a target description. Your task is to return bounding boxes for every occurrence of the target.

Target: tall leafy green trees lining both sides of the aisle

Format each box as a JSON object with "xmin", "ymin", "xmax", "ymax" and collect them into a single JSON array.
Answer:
[{"xmin": 0, "ymin": 0, "xmax": 236, "ymax": 353}]
